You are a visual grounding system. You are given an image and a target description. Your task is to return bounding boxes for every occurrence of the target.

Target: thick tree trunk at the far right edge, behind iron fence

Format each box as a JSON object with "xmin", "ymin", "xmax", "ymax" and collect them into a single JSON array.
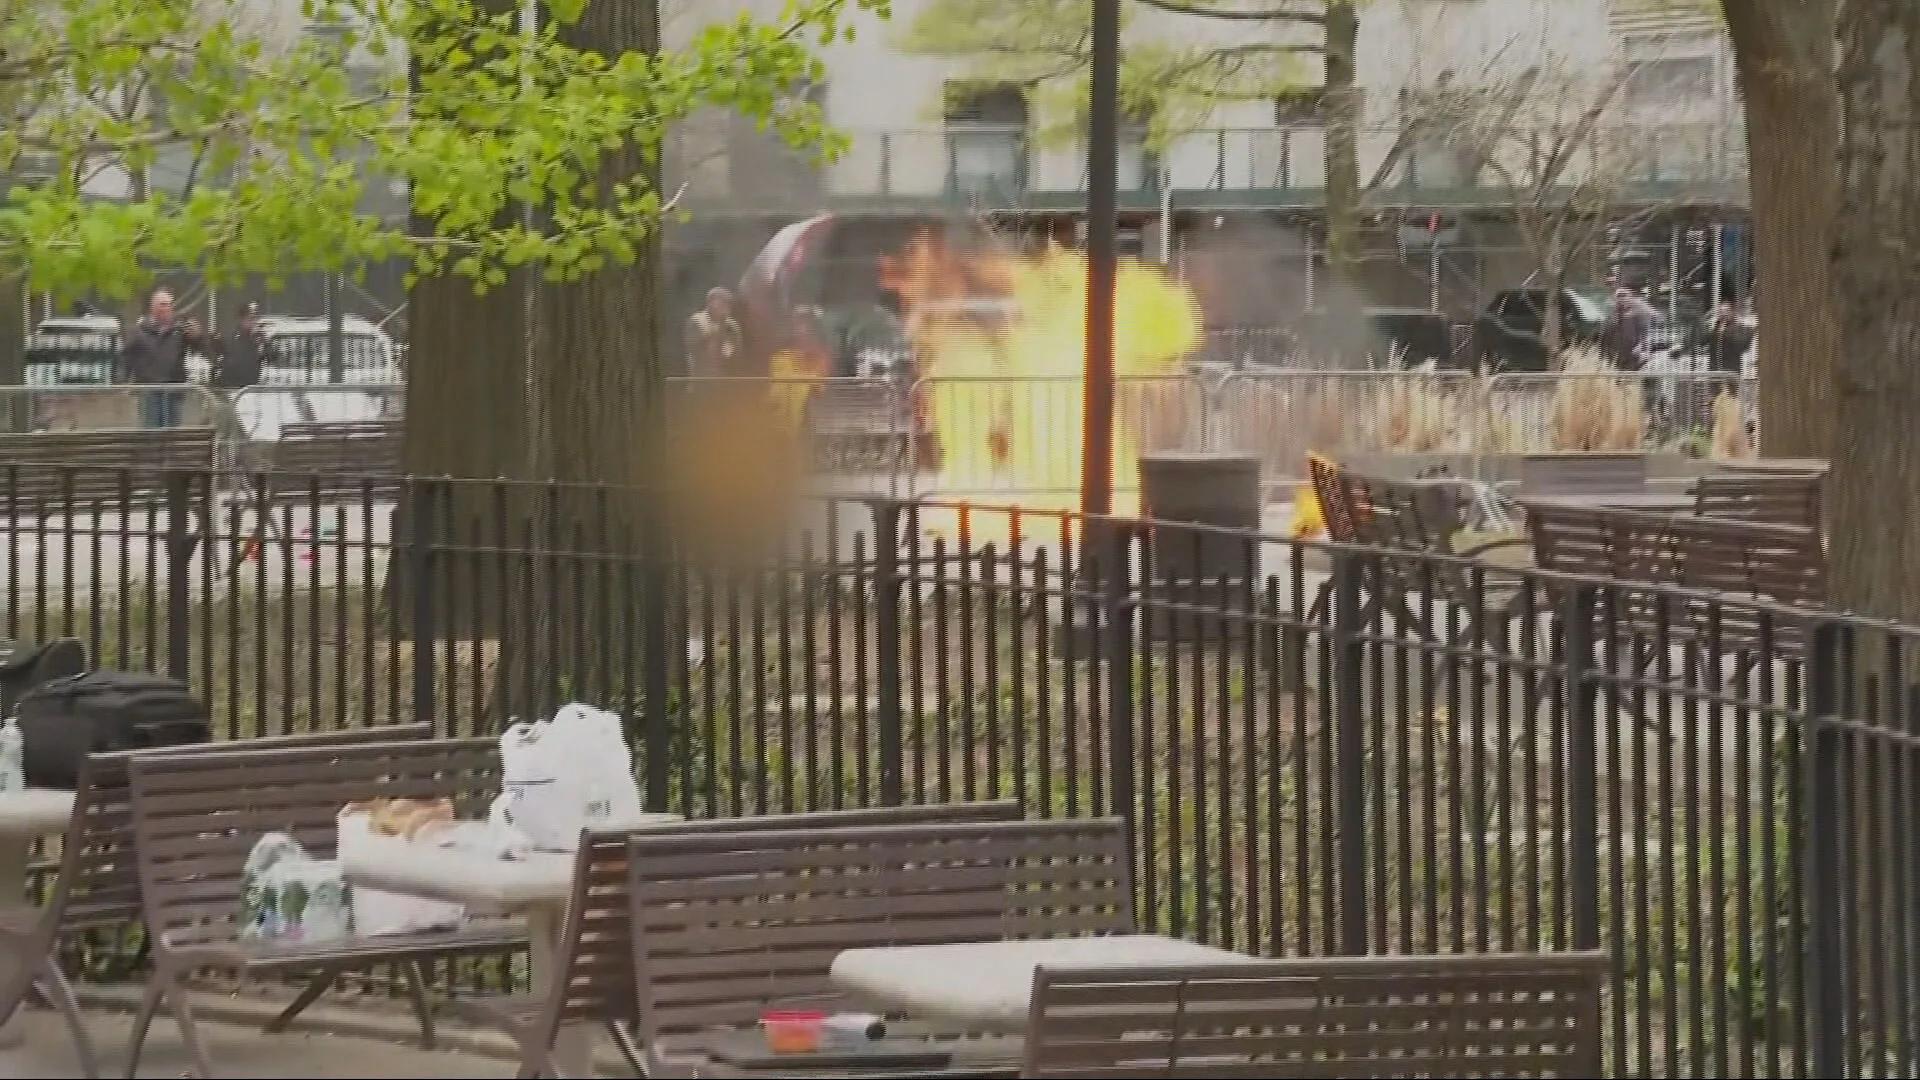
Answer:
[{"xmin": 1826, "ymin": 0, "xmax": 1920, "ymax": 1045}]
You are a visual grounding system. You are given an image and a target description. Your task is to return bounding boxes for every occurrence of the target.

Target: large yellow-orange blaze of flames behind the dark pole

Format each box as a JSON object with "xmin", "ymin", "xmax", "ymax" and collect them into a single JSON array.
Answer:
[{"xmin": 881, "ymin": 234, "xmax": 1202, "ymax": 530}]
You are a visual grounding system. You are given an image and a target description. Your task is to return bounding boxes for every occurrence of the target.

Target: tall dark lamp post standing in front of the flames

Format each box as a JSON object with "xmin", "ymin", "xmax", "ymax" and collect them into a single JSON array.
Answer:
[{"xmin": 1081, "ymin": 0, "xmax": 1119, "ymax": 515}]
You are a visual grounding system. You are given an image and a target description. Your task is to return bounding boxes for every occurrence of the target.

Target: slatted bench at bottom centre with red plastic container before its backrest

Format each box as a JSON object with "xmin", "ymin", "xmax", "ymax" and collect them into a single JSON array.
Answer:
[{"xmin": 628, "ymin": 819, "xmax": 1135, "ymax": 1076}]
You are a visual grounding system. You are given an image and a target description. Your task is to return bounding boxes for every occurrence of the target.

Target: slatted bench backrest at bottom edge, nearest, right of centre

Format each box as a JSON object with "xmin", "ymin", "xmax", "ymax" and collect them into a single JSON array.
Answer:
[{"xmin": 1020, "ymin": 951, "xmax": 1611, "ymax": 1080}]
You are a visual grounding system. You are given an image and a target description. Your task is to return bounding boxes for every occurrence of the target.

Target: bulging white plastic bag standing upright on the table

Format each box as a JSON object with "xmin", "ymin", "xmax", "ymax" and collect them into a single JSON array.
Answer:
[{"xmin": 490, "ymin": 701, "xmax": 641, "ymax": 851}]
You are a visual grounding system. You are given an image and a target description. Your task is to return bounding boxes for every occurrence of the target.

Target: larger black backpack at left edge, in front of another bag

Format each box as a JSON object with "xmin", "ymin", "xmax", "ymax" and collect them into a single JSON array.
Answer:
[{"xmin": 17, "ymin": 671, "xmax": 213, "ymax": 790}]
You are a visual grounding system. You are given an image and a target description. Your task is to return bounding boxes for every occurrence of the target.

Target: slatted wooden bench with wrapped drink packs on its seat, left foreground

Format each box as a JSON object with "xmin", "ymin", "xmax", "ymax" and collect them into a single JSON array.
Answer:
[{"xmin": 129, "ymin": 726, "xmax": 528, "ymax": 1076}]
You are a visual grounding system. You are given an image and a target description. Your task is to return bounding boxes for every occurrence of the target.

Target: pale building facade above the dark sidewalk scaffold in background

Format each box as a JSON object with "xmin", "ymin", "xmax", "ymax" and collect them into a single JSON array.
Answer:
[{"xmin": 682, "ymin": 0, "xmax": 1745, "ymax": 213}]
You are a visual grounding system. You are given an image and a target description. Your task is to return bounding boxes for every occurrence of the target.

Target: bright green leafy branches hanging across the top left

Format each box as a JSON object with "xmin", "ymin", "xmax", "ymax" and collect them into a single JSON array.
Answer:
[{"xmin": 0, "ymin": 0, "xmax": 871, "ymax": 296}]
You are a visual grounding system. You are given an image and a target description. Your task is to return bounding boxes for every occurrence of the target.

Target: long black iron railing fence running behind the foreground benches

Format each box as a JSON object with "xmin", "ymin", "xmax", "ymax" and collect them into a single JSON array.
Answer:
[{"xmin": 0, "ymin": 457, "xmax": 1920, "ymax": 1076}]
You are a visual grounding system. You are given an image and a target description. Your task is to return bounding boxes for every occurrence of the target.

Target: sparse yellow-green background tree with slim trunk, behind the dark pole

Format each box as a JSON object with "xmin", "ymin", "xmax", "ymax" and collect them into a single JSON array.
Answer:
[{"xmin": 902, "ymin": 0, "xmax": 1361, "ymax": 315}]
